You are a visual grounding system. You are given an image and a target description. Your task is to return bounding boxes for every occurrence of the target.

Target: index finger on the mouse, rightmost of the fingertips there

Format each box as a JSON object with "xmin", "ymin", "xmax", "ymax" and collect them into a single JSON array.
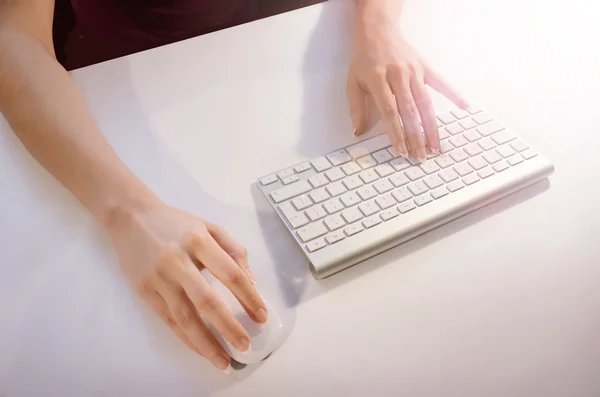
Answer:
[{"xmin": 188, "ymin": 233, "xmax": 268, "ymax": 323}]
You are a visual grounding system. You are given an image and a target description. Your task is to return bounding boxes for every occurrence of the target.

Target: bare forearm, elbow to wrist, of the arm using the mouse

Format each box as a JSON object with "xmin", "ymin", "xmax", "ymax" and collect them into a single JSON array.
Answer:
[{"xmin": 0, "ymin": 29, "xmax": 156, "ymax": 224}]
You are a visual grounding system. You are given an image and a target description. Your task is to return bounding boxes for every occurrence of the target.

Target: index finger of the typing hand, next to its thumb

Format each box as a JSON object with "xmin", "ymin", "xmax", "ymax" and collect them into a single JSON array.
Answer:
[{"xmin": 370, "ymin": 78, "xmax": 408, "ymax": 157}]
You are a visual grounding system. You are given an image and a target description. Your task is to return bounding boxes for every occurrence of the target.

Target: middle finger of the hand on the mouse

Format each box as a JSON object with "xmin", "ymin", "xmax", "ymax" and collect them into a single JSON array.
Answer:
[{"xmin": 166, "ymin": 258, "xmax": 250, "ymax": 352}]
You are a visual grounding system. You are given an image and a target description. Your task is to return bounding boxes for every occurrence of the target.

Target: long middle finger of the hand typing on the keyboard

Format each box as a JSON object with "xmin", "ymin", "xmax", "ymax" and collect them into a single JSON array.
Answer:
[{"xmin": 388, "ymin": 66, "xmax": 427, "ymax": 162}]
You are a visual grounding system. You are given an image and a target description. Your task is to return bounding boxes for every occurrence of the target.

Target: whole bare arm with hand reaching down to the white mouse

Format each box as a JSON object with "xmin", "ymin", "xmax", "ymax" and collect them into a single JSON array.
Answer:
[{"xmin": 0, "ymin": 0, "xmax": 267, "ymax": 371}]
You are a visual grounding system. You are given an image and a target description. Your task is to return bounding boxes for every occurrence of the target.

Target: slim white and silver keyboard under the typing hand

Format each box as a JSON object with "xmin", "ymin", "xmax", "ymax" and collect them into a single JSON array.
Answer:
[{"xmin": 258, "ymin": 108, "xmax": 554, "ymax": 278}]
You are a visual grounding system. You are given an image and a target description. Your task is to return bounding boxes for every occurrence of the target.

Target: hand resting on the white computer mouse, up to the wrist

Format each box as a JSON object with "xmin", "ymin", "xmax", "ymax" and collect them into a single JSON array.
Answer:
[{"xmin": 109, "ymin": 202, "xmax": 268, "ymax": 373}]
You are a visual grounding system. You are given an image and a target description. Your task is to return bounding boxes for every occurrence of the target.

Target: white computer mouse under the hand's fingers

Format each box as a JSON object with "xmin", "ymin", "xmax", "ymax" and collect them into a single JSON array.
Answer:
[{"xmin": 205, "ymin": 275, "xmax": 283, "ymax": 364}]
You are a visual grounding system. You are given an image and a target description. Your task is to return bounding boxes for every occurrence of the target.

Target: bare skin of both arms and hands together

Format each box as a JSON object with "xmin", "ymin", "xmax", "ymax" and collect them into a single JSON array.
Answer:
[{"xmin": 0, "ymin": 0, "xmax": 466, "ymax": 373}]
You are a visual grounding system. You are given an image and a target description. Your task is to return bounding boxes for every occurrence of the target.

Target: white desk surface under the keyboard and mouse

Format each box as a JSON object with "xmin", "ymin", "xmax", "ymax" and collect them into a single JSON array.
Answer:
[{"xmin": 0, "ymin": 0, "xmax": 600, "ymax": 397}]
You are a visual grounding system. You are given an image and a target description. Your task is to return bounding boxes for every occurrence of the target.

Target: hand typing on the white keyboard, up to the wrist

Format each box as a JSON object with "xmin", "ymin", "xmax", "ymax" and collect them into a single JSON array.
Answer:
[{"xmin": 347, "ymin": 17, "xmax": 469, "ymax": 162}]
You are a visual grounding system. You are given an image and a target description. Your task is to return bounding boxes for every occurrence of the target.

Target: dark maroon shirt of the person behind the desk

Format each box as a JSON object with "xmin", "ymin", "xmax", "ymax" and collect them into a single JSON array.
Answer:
[{"xmin": 71, "ymin": 0, "xmax": 257, "ymax": 67}]
